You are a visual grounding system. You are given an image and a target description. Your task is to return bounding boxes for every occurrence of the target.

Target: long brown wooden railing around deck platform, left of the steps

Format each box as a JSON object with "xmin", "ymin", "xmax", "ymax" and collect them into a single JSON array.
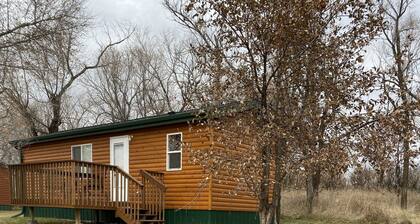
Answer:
[{"xmin": 9, "ymin": 161, "xmax": 144, "ymax": 209}]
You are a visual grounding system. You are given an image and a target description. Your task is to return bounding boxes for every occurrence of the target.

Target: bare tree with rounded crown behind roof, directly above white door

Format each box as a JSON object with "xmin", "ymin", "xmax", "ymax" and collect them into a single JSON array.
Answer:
[{"xmin": 85, "ymin": 46, "xmax": 147, "ymax": 123}]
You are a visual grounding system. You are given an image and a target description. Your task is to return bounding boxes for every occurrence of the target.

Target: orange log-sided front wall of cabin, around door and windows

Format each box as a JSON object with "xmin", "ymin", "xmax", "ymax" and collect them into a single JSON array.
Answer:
[{"xmin": 23, "ymin": 124, "xmax": 210, "ymax": 210}]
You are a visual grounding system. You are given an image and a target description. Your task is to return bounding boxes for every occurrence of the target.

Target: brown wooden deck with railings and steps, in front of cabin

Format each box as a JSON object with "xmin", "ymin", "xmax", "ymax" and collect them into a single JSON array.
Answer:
[{"xmin": 9, "ymin": 160, "xmax": 165, "ymax": 223}]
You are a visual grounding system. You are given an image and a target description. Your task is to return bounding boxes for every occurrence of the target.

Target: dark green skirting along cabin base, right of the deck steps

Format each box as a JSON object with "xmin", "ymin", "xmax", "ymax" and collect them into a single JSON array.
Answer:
[{"xmin": 165, "ymin": 209, "xmax": 259, "ymax": 224}]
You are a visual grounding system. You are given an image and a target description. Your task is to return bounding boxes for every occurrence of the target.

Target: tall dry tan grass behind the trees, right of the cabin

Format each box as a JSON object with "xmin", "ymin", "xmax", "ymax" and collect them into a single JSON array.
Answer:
[{"xmin": 282, "ymin": 190, "xmax": 420, "ymax": 224}]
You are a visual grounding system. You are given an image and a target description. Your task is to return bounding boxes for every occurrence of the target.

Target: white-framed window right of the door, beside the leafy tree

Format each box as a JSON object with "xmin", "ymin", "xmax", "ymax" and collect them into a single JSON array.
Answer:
[{"xmin": 166, "ymin": 133, "xmax": 182, "ymax": 171}]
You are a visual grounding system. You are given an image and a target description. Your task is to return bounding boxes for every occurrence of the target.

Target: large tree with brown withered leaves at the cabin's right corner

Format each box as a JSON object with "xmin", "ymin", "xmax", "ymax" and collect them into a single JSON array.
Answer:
[{"xmin": 165, "ymin": 0, "xmax": 381, "ymax": 224}]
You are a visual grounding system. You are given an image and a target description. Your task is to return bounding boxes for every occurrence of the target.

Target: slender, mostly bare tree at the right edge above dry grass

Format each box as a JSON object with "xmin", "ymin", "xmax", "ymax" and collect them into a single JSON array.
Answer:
[{"xmin": 379, "ymin": 0, "xmax": 420, "ymax": 209}]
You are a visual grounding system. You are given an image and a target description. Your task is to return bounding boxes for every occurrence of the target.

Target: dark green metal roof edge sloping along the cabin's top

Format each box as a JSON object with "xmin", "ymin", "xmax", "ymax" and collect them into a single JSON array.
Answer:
[{"xmin": 10, "ymin": 110, "xmax": 197, "ymax": 147}]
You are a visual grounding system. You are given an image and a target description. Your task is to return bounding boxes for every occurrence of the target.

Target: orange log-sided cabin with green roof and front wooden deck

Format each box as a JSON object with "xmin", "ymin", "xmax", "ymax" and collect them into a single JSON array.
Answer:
[{"xmin": 4, "ymin": 112, "xmax": 258, "ymax": 224}]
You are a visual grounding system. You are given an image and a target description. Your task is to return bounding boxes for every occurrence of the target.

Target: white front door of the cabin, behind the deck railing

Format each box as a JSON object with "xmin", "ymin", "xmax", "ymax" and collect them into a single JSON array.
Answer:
[{"xmin": 109, "ymin": 136, "xmax": 129, "ymax": 201}]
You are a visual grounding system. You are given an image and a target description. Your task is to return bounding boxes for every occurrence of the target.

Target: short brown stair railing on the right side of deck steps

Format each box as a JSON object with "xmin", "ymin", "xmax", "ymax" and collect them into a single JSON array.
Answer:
[{"xmin": 140, "ymin": 170, "xmax": 166, "ymax": 220}]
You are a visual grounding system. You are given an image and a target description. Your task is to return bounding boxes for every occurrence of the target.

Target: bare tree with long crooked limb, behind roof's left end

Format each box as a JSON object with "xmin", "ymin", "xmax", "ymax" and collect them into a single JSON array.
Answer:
[{"xmin": 3, "ymin": 7, "xmax": 129, "ymax": 136}]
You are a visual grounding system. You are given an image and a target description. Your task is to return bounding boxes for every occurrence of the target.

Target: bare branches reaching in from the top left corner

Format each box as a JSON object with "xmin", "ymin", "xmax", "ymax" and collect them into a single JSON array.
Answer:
[{"xmin": 0, "ymin": 0, "xmax": 83, "ymax": 51}]
